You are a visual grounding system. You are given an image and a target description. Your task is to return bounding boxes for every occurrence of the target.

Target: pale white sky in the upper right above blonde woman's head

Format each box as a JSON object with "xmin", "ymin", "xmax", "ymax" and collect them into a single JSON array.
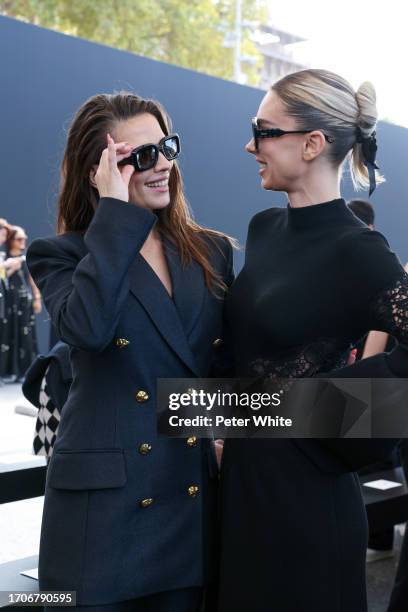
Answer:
[{"xmin": 268, "ymin": 0, "xmax": 408, "ymax": 127}]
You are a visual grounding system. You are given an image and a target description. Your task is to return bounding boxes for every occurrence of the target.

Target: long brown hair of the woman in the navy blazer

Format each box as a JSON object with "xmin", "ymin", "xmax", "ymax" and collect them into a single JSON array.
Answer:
[{"xmin": 57, "ymin": 92, "xmax": 236, "ymax": 291}]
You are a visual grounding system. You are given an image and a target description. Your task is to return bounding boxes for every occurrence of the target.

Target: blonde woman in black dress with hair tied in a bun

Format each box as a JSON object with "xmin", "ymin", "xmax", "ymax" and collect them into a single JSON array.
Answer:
[{"xmin": 219, "ymin": 70, "xmax": 408, "ymax": 612}]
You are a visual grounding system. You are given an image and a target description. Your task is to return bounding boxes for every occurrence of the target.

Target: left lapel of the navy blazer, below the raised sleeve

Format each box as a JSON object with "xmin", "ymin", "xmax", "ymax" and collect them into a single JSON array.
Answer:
[{"xmin": 129, "ymin": 253, "xmax": 201, "ymax": 376}]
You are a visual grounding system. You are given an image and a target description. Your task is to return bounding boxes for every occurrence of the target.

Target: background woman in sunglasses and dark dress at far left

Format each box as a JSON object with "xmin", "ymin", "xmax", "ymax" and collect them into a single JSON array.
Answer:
[{"xmin": 4, "ymin": 225, "xmax": 41, "ymax": 382}]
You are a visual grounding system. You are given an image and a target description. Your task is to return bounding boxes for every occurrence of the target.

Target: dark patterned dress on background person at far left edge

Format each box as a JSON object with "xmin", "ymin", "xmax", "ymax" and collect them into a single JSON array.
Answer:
[{"xmin": 2, "ymin": 262, "xmax": 38, "ymax": 380}]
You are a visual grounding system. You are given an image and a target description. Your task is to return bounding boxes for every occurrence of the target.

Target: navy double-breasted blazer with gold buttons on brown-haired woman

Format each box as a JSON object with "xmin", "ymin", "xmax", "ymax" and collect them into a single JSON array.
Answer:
[{"xmin": 27, "ymin": 198, "xmax": 232, "ymax": 605}]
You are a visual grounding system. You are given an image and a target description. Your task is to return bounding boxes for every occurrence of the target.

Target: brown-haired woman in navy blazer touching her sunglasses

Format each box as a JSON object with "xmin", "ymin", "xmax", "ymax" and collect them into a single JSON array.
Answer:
[{"xmin": 27, "ymin": 93, "xmax": 232, "ymax": 612}]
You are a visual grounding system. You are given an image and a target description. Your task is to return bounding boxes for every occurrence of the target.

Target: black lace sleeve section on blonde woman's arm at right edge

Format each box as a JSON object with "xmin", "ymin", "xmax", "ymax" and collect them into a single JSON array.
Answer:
[{"xmin": 371, "ymin": 274, "xmax": 408, "ymax": 344}]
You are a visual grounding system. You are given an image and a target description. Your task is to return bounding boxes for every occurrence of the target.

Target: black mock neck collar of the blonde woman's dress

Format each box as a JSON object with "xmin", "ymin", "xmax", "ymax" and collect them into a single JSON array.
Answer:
[{"xmin": 287, "ymin": 198, "xmax": 355, "ymax": 229}]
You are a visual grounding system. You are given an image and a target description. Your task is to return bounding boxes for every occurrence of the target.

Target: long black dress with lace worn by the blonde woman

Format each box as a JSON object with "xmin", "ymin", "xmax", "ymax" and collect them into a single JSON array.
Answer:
[{"xmin": 219, "ymin": 199, "xmax": 408, "ymax": 612}]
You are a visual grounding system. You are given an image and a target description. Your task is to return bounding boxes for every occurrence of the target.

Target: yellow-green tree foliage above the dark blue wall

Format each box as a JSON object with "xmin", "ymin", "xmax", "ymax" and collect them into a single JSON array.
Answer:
[{"xmin": 0, "ymin": 0, "xmax": 267, "ymax": 84}]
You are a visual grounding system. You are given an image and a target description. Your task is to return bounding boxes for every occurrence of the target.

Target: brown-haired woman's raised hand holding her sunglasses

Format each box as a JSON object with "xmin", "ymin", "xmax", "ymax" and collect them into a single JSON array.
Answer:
[{"xmin": 95, "ymin": 134, "xmax": 135, "ymax": 202}]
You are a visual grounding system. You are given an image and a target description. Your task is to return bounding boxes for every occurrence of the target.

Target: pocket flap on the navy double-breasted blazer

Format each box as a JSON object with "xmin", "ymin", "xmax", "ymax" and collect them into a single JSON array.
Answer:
[{"xmin": 47, "ymin": 449, "xmax": 127, "ymax": 490}]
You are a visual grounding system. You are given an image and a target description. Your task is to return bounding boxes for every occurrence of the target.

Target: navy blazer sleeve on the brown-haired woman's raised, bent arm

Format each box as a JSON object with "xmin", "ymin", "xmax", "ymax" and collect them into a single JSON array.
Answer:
[{"xmin": 27, "ymin": 198, "xmax": 156, "ymax": 352}]
